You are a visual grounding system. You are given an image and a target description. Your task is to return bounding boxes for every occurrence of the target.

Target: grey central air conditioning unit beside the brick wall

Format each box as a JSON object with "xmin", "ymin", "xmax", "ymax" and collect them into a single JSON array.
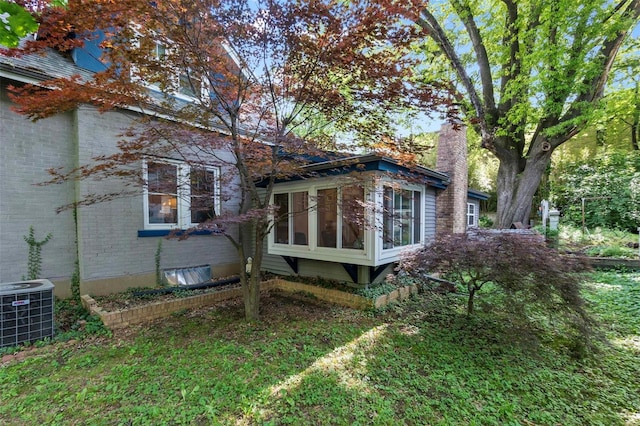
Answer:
[{"xmin": 0, "ymin": 280, "xmax": 55, "ymax": 347}]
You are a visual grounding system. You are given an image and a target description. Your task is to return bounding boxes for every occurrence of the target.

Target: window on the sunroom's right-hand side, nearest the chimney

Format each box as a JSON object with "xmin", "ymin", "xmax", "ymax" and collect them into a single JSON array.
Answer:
[{"xmin": 382, "ymin": 186, "xmax": 422, "ymax": 249}]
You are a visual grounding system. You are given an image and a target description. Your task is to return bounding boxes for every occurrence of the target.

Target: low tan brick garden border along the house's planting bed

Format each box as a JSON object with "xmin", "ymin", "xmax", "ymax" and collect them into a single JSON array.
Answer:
[{"xmin": 81, "ymin": 278, "xmax": 418, "ymax": 330}]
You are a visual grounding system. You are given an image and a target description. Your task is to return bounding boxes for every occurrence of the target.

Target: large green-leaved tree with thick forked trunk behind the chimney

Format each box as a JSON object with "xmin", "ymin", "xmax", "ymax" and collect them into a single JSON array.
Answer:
[{"xmin": 411, "ymin": 0, "xmax": 640, "ymax": 228}]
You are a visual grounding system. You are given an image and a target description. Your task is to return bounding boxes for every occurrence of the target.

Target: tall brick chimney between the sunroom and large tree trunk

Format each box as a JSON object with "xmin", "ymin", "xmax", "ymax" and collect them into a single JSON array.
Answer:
[{"xmin": 436, "ymin": 124, "xmax": 468, "ymax": 235}]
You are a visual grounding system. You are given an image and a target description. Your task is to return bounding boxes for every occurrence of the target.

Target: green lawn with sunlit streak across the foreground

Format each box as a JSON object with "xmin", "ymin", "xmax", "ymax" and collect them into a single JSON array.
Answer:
[{"xmin": 0, "ymin": 272, "xmax": 640, "ymax": 425}]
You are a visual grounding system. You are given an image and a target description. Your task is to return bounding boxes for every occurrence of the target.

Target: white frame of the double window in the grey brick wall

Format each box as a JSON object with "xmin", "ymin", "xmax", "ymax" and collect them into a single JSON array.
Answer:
[{"xmin": 142, "ymin": 158, "xmax": 221, "ymax": 230}]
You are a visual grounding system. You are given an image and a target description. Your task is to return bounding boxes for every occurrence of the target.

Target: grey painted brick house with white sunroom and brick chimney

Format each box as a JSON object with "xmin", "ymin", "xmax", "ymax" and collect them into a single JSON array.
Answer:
[{"xmin": 0, "ymin": 43, "xmax": 487, "ymax": 297}]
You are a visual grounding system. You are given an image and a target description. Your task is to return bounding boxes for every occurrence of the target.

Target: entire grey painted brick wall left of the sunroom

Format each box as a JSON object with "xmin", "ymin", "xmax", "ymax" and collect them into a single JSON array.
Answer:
[{"xmin": 0, "ymin": 81, "xmax": 241, "ymax": 288}]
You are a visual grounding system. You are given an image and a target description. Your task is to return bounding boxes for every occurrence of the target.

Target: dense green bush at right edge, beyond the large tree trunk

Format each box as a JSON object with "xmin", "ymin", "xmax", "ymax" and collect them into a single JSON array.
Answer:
[{"xmin": 551, "ymin": 152, "xmax": 640, "ymax": 231}]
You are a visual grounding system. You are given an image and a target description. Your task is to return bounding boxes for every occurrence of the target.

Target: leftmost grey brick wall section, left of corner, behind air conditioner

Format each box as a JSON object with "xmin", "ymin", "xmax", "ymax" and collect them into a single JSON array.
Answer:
[{"xmin": 0, "ymin": 79, "xmax": 75, "ymax": 282}]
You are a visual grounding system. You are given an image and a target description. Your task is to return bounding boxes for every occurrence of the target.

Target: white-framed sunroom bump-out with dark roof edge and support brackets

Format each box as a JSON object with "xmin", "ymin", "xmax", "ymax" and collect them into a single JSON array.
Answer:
[{"xmin": 263, "ymin": 155, "xmax": 448, "ymax": 284}]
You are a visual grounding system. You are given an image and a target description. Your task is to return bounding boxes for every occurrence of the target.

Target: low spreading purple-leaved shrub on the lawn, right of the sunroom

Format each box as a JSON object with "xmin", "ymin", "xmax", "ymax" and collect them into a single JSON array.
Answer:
[{"xmin": 400, "ymin": 230, "xmax": 589, "ymax": 352}]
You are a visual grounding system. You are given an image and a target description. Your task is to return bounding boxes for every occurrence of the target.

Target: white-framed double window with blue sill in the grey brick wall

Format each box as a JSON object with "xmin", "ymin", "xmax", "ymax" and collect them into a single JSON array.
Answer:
[{"xmin": 144, "ymin": 161, "xmax": 220, "ymax": 229}]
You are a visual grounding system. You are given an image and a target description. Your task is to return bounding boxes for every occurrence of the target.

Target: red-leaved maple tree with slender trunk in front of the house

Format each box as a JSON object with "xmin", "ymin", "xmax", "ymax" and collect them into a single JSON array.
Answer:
[{"xmin": 8, "ymin": 0, "xmax": 440, "ymax": 320}]
